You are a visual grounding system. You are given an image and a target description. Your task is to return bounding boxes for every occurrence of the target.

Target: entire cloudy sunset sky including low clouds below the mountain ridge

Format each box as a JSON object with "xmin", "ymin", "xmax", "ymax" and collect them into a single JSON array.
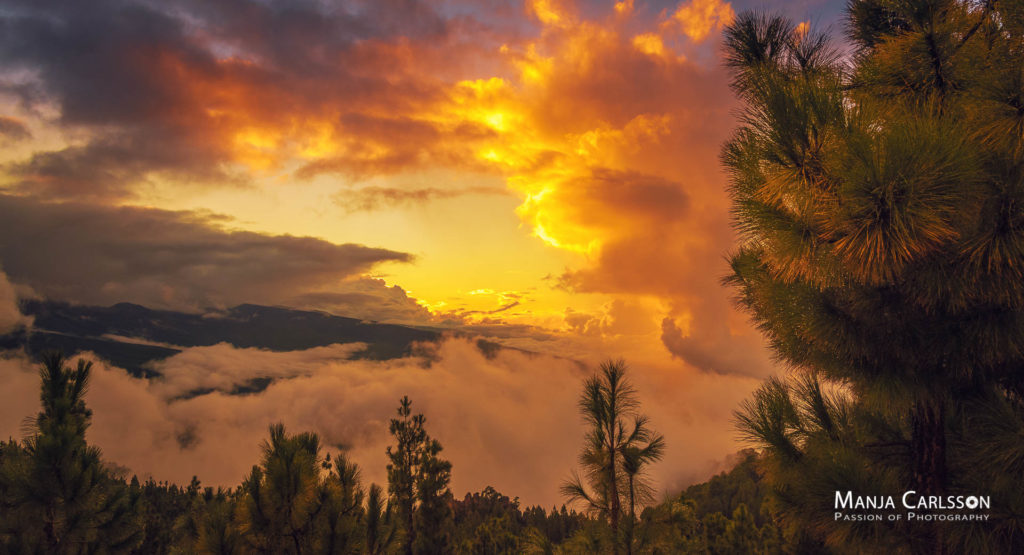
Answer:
[{"xmin": 0, "ymin": 0, "xmax": 843, "ymax": 504}]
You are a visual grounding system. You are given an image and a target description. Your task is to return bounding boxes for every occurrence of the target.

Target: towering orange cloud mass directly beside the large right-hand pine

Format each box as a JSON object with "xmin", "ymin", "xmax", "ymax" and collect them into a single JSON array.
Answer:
[{"xmin": 456, "ymin": 1, "xmax": 770, "ymax": 375}]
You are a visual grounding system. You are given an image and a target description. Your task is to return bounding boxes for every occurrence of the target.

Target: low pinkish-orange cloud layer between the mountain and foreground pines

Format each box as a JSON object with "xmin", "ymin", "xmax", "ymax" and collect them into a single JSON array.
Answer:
[{"xmin": 0, "ymin": 340, "xmax": 754, "ymax": 506}]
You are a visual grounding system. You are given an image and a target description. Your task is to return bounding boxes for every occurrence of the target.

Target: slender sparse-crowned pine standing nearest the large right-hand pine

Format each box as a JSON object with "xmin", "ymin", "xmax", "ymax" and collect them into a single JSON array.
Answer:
[{"xmin": 562, "ymin": 360, "xmax": 665, "ymax": 553}]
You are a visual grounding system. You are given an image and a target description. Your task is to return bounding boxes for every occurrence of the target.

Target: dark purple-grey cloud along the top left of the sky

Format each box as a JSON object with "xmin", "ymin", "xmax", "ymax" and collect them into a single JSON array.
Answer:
[{"xmin": 0, "ymin": 0, "xmax": 444, "ymax": 120}]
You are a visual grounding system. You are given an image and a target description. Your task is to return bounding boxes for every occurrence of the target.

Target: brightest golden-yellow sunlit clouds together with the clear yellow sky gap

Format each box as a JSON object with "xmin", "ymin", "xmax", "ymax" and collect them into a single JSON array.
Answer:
[{"xmin": 49, "ymin": 0, "xmax": 734, "ymax": 344}]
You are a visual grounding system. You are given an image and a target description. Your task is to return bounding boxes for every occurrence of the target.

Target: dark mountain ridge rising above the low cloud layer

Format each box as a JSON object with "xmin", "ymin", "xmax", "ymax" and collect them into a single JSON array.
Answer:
[{"xmin": 0, "ymin": 300, "xmax": 441, "ymax": 377}]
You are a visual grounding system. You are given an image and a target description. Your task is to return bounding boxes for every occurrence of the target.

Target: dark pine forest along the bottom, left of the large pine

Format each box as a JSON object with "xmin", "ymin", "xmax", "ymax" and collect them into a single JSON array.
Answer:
[{"xmin": 0, "ymin": 355, "xmax": 792, "ymax": 554}]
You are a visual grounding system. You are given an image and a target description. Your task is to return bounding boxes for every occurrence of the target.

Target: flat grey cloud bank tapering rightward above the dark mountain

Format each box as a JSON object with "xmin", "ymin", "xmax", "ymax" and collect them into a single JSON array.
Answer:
[{"xmin": 0, "ymin": 196, "xmax": 412, "ymax": 309}]
